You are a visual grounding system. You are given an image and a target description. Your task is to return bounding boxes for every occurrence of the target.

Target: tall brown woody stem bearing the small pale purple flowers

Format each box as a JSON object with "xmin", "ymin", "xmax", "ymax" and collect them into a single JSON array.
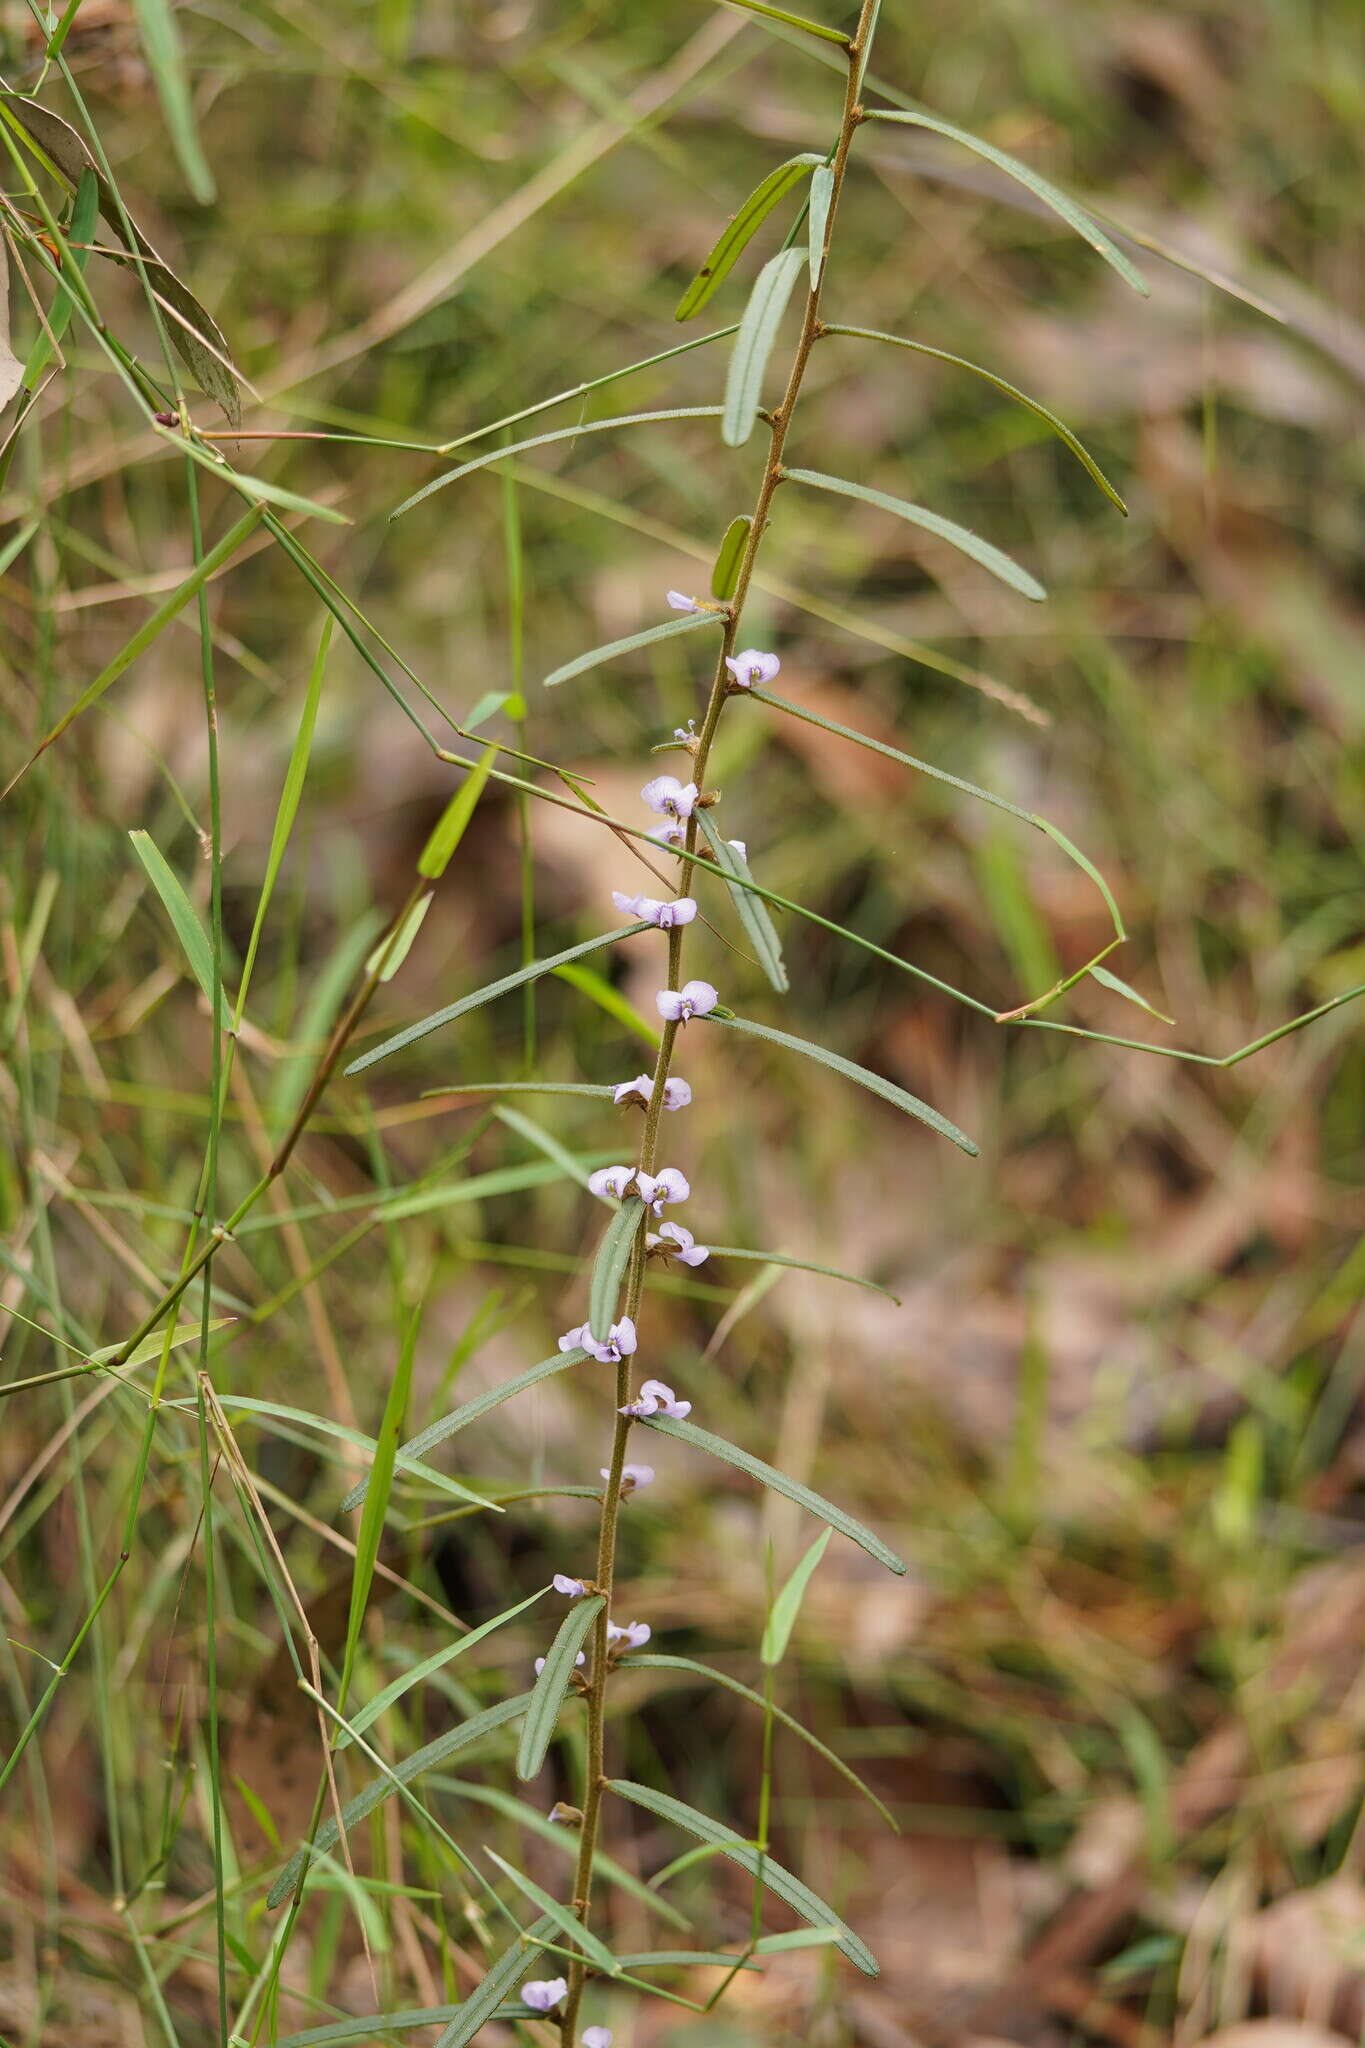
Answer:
[{"xmin": 561, "ymin": 0, "xmax": 878, "ymax": 2048}]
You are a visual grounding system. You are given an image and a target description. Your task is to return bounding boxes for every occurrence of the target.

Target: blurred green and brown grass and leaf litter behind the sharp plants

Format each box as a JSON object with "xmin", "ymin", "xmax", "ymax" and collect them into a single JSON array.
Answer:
[{"xmin": 0, "ymin": 0, "xmax": 1365, "ymax": 2048}]
